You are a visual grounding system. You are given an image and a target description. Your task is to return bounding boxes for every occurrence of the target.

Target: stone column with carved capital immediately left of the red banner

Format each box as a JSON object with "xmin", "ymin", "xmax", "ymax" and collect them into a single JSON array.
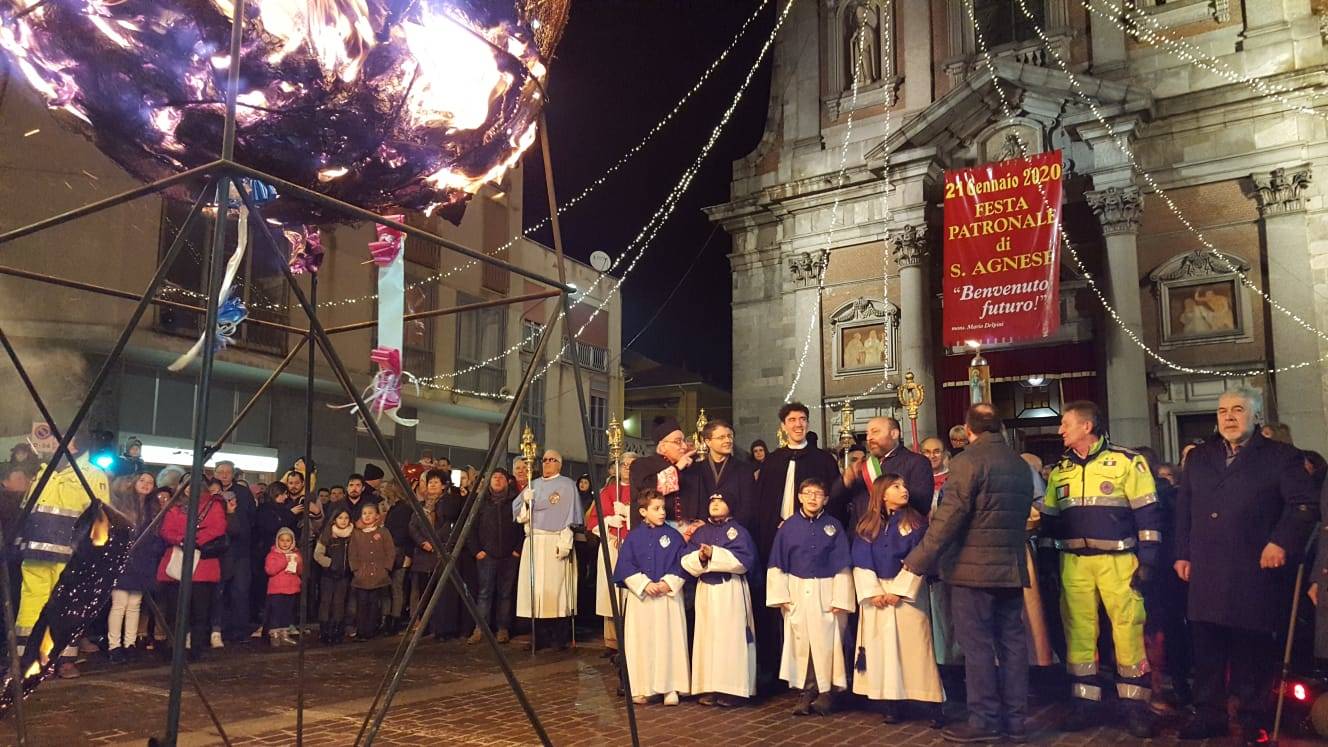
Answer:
[{"xmin": 890, "ymin": 222, "xmax": 940, "ymax": 443}]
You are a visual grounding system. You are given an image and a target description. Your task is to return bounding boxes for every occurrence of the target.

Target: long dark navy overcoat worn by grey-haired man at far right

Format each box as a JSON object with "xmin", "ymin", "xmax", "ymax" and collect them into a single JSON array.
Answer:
[{"xmin": 1175, "ymin": 431, "xmax": 1319, "ymax": 633}]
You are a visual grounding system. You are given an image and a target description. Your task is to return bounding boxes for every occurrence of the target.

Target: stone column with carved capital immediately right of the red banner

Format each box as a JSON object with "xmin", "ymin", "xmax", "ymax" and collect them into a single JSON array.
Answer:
[{"xmin": 1084, "ymin": 186, "xmax": 1153, "ymax": 447}]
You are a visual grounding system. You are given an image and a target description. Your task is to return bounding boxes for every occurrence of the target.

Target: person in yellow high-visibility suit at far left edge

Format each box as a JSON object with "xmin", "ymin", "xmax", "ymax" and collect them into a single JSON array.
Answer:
[{"xmin": 13, "ymin": 439, "xmax": 110, "ymax": 678}]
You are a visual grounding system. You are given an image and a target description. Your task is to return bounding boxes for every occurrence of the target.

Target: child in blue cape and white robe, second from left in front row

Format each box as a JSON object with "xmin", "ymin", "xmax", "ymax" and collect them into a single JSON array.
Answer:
[{"xmin": 683, "ymin": 493, "xmax": 757, "ymax": 707}]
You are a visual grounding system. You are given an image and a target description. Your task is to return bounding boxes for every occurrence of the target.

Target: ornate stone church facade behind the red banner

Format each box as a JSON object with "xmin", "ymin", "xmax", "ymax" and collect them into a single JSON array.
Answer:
[{"xmin": 708, "ymin": 0, "xmax": 1328, "ymax": 459}]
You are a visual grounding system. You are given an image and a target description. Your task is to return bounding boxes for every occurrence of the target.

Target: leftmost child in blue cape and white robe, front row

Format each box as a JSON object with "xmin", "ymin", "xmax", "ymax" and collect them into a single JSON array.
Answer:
[{"xmin": 614, "ymin": 490, "xmax": 688, "ymax": 706}]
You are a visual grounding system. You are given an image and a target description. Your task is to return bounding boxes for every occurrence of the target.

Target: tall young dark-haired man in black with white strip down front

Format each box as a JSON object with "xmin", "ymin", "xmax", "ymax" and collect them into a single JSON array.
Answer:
[{"xmin": 752, "ymin": 401, "xmax": 841, "ymax": 694}]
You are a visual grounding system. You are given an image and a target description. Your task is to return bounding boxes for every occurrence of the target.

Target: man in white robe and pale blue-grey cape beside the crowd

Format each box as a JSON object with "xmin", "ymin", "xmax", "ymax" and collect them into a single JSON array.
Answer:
[{"xmin": 511, "ymin": 449, "xmax": 583, "ymax": 650}]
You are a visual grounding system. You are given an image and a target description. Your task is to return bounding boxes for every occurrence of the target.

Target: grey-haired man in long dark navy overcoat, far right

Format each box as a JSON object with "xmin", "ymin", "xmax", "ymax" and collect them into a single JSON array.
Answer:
[{"xmin": 1175, "ymin": 389, "xmax": 1319, "ymax": 744}]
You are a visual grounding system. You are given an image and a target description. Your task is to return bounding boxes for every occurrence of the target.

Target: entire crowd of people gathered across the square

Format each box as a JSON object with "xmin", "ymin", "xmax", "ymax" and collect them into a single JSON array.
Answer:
[{"xmin": 0, "ymin": 380, "xmax": 1328, "ymax": 743}]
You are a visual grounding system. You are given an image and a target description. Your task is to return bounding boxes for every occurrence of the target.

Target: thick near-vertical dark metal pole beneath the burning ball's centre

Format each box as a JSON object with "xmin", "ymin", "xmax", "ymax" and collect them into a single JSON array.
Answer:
[{"xmin": 165, "ymin": 175, "xmax": 231, "ymax": 747}]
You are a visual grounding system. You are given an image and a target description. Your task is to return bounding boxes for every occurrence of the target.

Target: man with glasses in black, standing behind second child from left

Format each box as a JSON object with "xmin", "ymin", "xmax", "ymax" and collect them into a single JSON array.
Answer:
[{"xmin": 683, "ymin": 419, "xmax": 756, "ymax": 537}]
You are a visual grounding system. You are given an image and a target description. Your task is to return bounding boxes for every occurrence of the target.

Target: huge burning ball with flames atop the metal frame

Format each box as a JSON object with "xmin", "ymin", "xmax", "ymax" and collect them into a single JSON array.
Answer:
[{"xmin": 0, "ymin": 0, "xmax": 570, "ymax": 222}]
